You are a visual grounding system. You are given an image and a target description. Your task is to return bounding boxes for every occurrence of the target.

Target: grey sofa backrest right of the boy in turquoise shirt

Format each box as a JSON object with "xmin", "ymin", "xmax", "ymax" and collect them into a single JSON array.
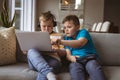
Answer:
[{"xmin": 90, "ymin": 33, "xmax": 120, "ymax": 65}]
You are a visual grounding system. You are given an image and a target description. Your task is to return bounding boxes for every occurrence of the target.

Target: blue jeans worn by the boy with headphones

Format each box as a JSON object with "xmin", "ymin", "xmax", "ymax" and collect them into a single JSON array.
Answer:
[{"xmin": 27, "ymin": 49, "xmax": 61, "ymax": 80}]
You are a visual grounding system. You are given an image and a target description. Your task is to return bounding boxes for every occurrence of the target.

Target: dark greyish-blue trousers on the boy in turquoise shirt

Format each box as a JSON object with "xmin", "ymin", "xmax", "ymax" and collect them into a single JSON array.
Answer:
[{"xmin": 69, "ymin": 60, "xmax": 106, "ymax": 80}]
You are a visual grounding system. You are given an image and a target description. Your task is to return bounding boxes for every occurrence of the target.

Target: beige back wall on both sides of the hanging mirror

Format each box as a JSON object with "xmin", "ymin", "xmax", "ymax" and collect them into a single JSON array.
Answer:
[{"xmin": 36, "ymin": 0, "xmax": 104, "ymax": 28}]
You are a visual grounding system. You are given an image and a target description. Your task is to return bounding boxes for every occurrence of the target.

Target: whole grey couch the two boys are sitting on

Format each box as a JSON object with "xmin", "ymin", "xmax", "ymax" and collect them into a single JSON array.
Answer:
[{"xmin": 0, "ymin": 33, "xmax": 120, "ymax": 80}]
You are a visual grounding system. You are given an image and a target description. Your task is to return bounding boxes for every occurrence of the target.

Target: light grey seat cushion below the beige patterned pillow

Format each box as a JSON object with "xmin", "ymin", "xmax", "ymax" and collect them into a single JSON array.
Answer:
[{"xmin": 0, "ymin": 63, "xmax": 37, "ymax": 80}]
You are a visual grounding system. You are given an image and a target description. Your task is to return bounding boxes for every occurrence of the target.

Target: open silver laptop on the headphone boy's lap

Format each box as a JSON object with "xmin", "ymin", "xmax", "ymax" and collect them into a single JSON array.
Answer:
[{"xmin": 16, "ymin": 31, "xmax": 52, "ymax": 52}]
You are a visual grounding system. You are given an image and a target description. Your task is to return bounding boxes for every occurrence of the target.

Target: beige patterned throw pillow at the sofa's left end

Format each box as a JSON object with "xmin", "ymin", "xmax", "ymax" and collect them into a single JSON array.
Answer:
[{"xmin": 0, "ymin": 27, "xmax": 16, "ymax": 65}]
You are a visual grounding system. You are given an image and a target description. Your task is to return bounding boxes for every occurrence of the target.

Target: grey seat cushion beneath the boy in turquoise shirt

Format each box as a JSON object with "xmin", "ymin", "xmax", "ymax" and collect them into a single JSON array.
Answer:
[{"xmin": 59, "ymin": 66, "xmax": 120, "ymax": 80}]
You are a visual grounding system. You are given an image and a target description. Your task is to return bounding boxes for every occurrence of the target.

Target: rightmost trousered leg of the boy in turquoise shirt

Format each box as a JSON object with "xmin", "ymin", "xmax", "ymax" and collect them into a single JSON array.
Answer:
[{"xmin": 86, "ymin": 60, "xmax": 106, "ymax": 80}]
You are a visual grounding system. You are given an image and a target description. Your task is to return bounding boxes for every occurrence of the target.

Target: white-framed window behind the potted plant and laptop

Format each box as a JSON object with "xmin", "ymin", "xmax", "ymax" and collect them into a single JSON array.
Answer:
[{"xmin": 9, "ymin": 0, "xmax": 36, "ymax": 31}]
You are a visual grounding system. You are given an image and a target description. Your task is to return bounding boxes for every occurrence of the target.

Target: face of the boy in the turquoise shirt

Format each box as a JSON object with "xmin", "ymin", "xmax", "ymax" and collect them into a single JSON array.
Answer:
[{"xmin": 63, "ymin": 20, "xmax": 79, "ymax": 37}]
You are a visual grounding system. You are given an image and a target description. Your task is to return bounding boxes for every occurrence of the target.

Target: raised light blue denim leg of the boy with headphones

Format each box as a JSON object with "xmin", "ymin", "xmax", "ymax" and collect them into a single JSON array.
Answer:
[{"xmin": 27, "ymin": 49, "xmax": 53, "ymax": 75}]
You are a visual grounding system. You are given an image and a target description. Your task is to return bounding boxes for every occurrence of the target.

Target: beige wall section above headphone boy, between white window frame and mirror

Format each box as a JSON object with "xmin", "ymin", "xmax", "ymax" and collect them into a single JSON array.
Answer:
[{"xmin": 36, "ymin": 0, "xmax": 59, "ymax": 19}]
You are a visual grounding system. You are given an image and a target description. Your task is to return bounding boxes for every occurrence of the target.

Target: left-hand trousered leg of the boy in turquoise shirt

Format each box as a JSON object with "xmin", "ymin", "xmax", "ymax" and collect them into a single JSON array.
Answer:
[{"xmin": 69, "ymin": 62, "xmax": 85, "ymax": 80}]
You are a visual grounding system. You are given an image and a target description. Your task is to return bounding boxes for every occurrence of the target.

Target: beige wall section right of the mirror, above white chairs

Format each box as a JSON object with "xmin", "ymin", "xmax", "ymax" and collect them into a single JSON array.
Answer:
[{"xmin": 84, "ymin": 0, "xmax": 104, "ymax": 28}]
